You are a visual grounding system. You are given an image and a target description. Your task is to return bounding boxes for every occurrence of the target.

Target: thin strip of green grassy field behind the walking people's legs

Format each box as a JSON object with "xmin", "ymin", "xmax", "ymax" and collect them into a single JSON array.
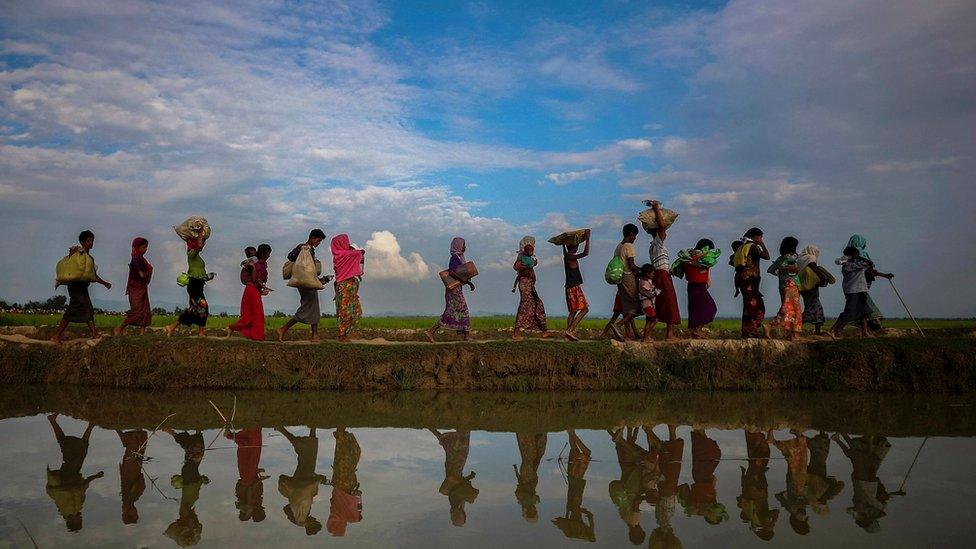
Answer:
[{"xmin": 0, "ymin": 313, "xmax": 976, "ymax": 331}]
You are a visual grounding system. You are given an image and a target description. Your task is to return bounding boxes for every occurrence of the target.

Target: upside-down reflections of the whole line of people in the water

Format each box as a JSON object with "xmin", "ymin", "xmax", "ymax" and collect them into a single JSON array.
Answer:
[{"xmin": 46, "ymin": 414, "xmax": 904, "ymax": 546}]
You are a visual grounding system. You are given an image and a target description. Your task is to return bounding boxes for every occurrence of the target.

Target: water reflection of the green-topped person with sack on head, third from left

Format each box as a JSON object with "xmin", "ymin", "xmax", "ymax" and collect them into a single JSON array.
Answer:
[{"xmin": 164, "ymin": 429, "xmax": 210, "ymax": 547}]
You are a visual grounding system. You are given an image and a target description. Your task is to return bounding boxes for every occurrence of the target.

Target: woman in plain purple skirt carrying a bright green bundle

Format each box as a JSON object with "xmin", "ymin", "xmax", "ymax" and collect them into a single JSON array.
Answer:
[{"xmin": 671, "ymin": 238, "xmax": 722, "ymax": 338}]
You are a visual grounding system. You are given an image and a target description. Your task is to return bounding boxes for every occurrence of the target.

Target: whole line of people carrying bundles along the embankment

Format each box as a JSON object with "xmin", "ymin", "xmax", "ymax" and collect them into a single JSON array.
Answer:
[{"xmin": 51, "ymin": 206, "xmax": 894, "ymax": 343}]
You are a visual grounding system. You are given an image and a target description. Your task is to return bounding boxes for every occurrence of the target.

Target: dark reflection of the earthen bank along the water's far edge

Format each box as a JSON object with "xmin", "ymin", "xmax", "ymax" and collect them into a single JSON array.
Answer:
[{"xmin": 0, "ymin": 385, "xmax": 976, "ymax": 437}]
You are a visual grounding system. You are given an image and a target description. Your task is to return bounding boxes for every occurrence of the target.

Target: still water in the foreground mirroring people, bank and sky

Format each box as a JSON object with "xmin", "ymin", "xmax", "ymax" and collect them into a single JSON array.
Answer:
[{"xmin": 0, "ymin": 388, "xmax": 976, "ymax": 547}]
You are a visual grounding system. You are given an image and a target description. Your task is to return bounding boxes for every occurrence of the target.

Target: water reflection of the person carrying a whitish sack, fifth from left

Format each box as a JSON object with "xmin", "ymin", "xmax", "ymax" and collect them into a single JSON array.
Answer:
[{"xmin": 275, "ymin": 427, "xmax": 326, "ymax": 536}]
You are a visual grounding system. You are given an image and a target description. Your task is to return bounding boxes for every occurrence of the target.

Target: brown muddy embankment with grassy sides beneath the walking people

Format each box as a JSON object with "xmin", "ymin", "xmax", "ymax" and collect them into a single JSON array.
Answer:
[{"xmin": 0, "ymin": 326, "xmax": 976, "ymax": 393}]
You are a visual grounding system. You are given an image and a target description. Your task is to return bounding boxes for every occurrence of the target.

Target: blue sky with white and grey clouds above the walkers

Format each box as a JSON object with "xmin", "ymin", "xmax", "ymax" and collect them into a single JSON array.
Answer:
[{"xmin": 0, "ymin": 0, "xmax": 976, "ymax": 317}]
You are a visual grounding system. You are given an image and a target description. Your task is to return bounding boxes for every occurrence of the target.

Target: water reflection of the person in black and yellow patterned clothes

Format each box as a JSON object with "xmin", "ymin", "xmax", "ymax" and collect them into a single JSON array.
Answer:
[{"xmin": 736, "ymin": 431, "xmax": 779, "ymax": 541}]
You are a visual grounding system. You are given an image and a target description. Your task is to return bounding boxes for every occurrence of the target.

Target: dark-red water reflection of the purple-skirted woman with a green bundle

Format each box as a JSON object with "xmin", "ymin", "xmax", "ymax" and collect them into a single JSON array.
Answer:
[{"xmin": 678, "ymin": 429, "xmax": 729, "ymax": 524}]
